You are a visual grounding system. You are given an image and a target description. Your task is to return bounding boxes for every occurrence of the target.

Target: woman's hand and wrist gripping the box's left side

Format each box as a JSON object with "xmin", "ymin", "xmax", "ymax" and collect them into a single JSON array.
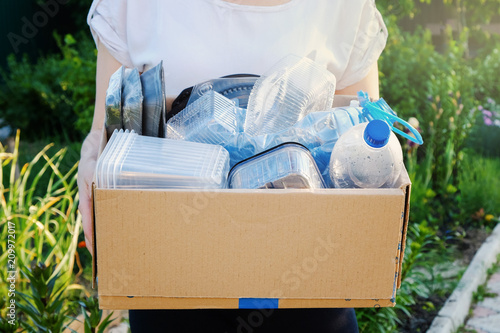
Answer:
[{"xmin": 78, "ymin": 130, "xmax": 102, "ymax": 255}]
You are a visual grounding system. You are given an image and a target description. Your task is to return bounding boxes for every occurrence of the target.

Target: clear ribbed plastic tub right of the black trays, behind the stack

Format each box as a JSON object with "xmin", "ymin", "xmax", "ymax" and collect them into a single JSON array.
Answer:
[{"xmin": 165, "ymin": 90, "xmax": 241, "ymax": 144}]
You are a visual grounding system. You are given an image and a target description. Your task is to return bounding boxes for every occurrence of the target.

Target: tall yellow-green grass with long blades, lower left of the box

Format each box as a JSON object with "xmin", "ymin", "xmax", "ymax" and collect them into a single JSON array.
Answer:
[{"xmin": 0, "ymin": 133, "xmax": 88, "ymax": 332}]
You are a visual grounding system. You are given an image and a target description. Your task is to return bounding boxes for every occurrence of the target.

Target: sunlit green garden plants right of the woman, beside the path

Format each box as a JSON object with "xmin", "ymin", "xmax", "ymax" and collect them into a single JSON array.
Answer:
[{"xmin": 357, "ymin": 0, "xmax": 500, "ymax": 332}]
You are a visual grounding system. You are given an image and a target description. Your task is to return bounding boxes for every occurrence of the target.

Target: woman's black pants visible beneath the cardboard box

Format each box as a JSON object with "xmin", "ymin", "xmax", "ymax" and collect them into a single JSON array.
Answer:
[{"xmin": 129, "ymin": 309, "xmax": 358, "ymax": 333}]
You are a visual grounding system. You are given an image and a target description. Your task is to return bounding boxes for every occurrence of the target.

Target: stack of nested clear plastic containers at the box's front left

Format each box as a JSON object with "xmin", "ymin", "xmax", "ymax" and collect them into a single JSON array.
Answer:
[{"xmin": 95, "ymin": 130, "xmax": 229, "ymax": 189}]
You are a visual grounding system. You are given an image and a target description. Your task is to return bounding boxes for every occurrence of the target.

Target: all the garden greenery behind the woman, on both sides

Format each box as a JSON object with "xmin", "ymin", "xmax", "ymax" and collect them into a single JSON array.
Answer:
[{"xmin": 0, "ymin": 0, "xmax": 500, "ymax": 332}]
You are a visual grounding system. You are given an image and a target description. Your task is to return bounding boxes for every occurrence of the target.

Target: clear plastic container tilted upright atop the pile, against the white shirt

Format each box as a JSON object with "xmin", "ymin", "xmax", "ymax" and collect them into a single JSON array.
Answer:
[{"xmin": 245, "ymin": 55, "xmax": 336, "ymax": 136}]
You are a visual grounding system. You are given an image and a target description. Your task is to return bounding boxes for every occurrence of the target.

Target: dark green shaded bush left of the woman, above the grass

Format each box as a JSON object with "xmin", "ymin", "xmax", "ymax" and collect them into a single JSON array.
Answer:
[{"xmin": 0, "ymin": 34, "xmax": 96, "ymax": 140}]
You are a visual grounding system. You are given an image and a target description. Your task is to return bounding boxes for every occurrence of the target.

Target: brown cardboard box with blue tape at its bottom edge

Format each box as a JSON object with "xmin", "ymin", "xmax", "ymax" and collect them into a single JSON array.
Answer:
[{"xmin": 94, "ymin": 96, "xmax": 411, "ymax": 309}]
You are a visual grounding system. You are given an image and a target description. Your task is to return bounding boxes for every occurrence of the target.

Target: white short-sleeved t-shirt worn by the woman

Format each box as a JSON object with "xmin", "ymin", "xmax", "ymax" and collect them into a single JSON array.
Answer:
[{"xmin": 87, "ymin": 0, "xmax": 387, "ymax": 97}]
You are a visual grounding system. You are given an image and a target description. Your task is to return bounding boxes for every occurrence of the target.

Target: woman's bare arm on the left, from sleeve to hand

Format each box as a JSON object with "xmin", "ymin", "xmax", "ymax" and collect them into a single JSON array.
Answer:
[{"xmin": 78, "ymin": 44, "xmax": 121, "ymax": 255}]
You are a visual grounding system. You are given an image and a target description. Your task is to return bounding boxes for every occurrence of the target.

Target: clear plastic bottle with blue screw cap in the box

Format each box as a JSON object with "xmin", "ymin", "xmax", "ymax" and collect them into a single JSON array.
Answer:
[{"xmin": 329, "ymin": 119, "xmax": 403, "ymax": 188}]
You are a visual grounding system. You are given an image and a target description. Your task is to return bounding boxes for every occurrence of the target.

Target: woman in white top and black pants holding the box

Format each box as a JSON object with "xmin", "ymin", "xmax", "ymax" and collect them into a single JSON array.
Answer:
[{"xmin": 78, "ymin": 0, "xmax": 387, "ymax": 332}]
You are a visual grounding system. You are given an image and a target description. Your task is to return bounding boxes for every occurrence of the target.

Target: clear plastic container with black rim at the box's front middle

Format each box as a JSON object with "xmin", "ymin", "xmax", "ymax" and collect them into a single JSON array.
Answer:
[{"xmin": 228, "ymin": 143, "xmax": 325, "ymax": 189}]
